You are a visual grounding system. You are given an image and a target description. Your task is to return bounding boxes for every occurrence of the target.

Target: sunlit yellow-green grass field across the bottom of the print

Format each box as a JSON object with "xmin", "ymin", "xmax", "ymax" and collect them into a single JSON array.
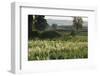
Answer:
[{"xmin": 28, "ymin": 36, "xmax": 88, "ymax": 61}]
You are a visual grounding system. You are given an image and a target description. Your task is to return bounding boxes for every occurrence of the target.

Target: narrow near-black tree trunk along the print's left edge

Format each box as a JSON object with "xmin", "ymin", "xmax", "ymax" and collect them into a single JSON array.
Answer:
[{"xmin": 28, "ymin": 15, "xmax": 33, "ymax": 38}]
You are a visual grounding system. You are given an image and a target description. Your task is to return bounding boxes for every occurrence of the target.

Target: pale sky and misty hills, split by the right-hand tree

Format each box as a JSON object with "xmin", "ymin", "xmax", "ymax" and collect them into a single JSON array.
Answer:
[{"xmin": 45, "ymin": 16, "xmax": 88, "ymax": 26}]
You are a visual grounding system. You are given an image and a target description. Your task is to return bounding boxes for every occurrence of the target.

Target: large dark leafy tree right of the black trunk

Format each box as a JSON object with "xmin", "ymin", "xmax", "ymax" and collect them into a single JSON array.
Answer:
[{"xmin": 34, "ymin": 15, "xmax": 48, "ymax": 31}]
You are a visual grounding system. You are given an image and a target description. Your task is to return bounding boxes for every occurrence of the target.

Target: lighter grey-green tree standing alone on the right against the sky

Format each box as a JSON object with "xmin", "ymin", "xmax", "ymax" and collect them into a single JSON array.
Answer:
[{"xmin": 73, "ymin": 17, "xmax": 83, "ymax": 32}]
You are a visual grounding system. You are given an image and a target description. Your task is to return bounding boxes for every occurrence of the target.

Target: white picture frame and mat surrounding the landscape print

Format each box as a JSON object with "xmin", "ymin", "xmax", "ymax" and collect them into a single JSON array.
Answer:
[{"xmin": 11, "ymin": 3, "xmax": 96, "ymax": 73}]
